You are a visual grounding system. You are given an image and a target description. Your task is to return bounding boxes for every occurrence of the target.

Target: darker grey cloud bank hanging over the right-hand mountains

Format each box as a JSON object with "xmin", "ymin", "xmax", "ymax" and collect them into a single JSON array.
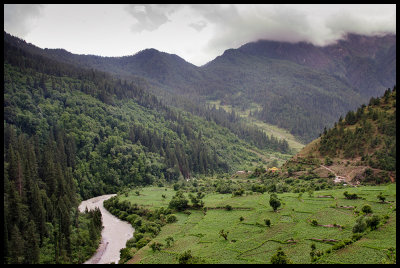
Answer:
[{"xmin": 191, "ymin": 5, "xmax": 396, "ymax": 54}]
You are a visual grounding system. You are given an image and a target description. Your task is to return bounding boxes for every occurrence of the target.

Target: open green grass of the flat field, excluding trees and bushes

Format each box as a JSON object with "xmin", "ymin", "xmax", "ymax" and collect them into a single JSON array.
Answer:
[{"xmin": 116, "ymin": 184, "xmax": 396, "ymax": 264}]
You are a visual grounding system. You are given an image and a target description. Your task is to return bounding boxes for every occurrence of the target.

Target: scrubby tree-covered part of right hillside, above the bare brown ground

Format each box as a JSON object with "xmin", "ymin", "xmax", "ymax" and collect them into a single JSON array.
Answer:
[{"xmin": 319, "ymin": 87, "xmax": 396, "ymax": 171}]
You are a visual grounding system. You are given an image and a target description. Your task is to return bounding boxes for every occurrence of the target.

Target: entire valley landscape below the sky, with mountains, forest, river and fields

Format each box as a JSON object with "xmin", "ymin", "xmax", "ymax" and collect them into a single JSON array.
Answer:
[{"xmin": 3, "ymin": 28, "xmax": 397, "ymax": 264}]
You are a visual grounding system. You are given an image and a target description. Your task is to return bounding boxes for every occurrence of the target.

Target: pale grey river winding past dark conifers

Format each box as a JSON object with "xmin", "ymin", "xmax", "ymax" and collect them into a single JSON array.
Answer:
[{"xmin": 79, "ymin": 194, "xmax": 135, "ymax": 264}]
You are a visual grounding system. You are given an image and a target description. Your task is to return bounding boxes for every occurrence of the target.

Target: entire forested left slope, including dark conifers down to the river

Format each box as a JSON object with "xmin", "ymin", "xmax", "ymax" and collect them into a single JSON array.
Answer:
[{"xmin": 3, "ymin": 30, "xmax": 289, "ymax": 263}]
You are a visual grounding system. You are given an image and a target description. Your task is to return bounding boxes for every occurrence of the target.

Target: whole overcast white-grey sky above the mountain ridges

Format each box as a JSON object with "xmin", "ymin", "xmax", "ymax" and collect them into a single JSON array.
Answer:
[{"xmin": 4, "ymin": 4, "xmax": 396, "ymax": 66}]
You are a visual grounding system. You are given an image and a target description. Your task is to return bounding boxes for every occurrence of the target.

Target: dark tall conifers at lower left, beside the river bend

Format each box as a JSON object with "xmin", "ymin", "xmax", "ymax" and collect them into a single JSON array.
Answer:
[{"xmin": 3, "ymin": 124, "xmax": 102, "ymax": 263}]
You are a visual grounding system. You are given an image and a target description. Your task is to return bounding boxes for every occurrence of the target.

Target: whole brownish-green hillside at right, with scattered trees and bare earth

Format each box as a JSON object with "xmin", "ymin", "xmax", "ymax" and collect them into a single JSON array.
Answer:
[{"xmin": 285, "ymin": 87, "xmax": 396, "ymax": 184}]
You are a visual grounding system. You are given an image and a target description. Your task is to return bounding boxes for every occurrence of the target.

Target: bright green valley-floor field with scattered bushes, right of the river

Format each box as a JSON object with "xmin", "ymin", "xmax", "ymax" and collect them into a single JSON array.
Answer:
[{"xmin": 104, "ymin": 182, "xmax": 396, "ymax": 264}]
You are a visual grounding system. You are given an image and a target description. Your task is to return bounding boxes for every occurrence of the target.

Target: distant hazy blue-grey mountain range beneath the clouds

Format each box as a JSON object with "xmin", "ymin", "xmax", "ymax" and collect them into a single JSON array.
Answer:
[{"xmin": 4, "ymin": 33, "xmax": 396, "ymax": 142}]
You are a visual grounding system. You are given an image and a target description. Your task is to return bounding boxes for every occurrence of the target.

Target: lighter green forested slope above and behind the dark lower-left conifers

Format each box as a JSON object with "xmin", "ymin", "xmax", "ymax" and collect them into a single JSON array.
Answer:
[{"xmin": 4, "ymin": 40, "xmax": 287, "ymax": 199}]
